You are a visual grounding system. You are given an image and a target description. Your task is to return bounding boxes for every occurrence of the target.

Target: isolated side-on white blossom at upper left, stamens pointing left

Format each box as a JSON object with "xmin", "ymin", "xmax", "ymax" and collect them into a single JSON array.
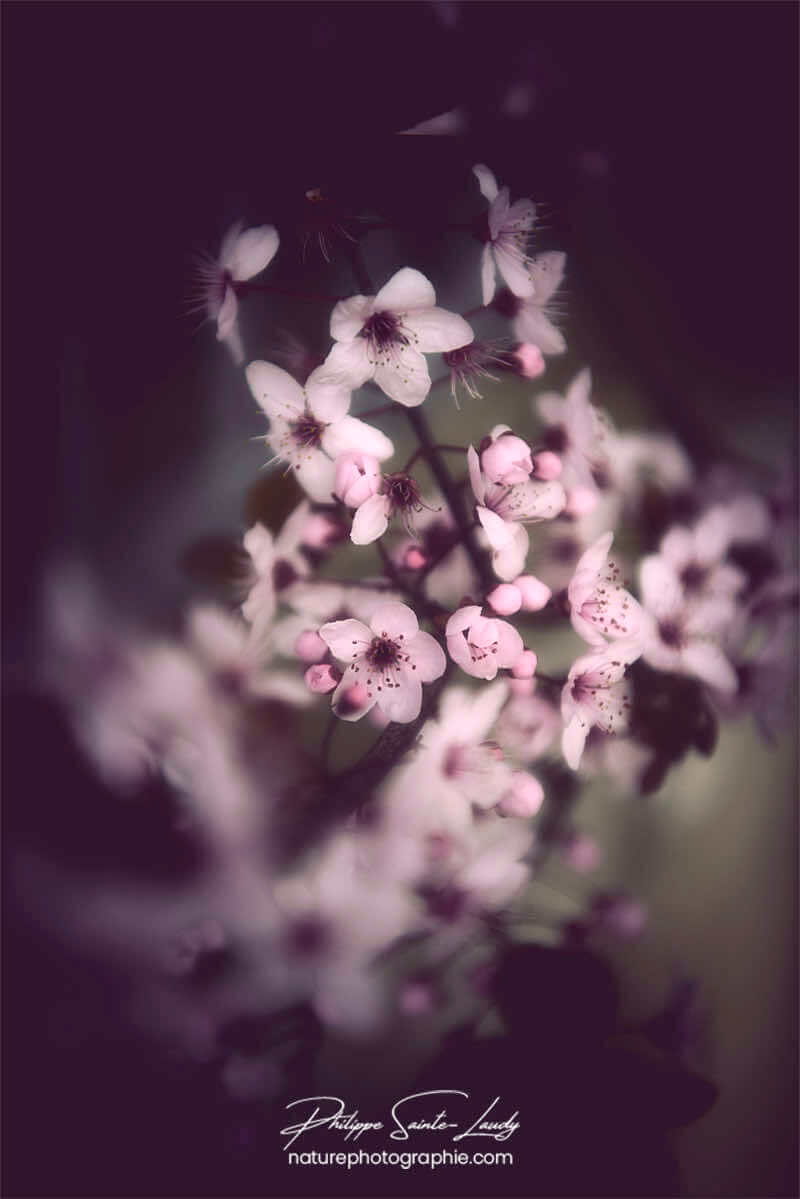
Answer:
[{"xmin": 198, "ymin": 222, "xmax": 278, "ymax": 366}]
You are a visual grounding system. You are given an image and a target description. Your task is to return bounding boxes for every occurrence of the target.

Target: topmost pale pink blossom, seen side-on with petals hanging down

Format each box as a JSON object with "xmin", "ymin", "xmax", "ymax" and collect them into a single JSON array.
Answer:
[{"xmin": 473, "ymin": 163, "xmax": 536, "ymax": 304}]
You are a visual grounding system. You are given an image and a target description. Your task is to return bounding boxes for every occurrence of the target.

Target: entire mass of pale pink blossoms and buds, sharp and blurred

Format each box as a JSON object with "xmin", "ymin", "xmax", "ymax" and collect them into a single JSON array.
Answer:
[{"xmin": 43, "ymin": 165, "xmax": 798, "ymax": 1098}]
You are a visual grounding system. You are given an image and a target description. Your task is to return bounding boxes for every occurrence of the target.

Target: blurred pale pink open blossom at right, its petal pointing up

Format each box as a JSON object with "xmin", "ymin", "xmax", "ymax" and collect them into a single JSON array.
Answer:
[{"xmin": 639, "ymin": 554, "xmax": 738, "ymax": 693}]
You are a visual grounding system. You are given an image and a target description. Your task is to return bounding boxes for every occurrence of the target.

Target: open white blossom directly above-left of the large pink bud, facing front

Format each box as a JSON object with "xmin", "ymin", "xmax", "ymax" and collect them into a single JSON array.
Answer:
[{"xmin": 246, "ymin": 362, "xmax": 395, "ymax": 504}]
